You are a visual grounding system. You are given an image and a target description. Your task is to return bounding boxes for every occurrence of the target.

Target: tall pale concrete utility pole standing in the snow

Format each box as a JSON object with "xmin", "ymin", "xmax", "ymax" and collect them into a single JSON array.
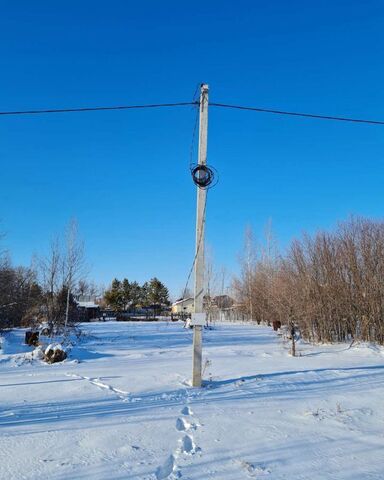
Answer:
[{"xmin": 192, "ymin": 83, "xmax": 208, "ymax": 387}]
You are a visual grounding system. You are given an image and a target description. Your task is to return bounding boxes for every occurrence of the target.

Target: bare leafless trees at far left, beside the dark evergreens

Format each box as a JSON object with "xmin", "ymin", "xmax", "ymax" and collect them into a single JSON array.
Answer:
[{"xmin": 0, "ymin": 221, "xmax": 87, "ymax": 333}]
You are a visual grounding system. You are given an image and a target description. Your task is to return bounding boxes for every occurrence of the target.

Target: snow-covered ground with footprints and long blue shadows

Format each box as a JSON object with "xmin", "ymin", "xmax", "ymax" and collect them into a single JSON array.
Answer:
[{"xmin": 0, "ymin": 322, "xmax": 384, "ymax": 480}]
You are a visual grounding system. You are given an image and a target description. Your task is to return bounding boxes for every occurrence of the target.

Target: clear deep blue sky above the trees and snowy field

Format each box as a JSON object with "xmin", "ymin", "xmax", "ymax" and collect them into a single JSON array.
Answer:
[{"xmin": 0, "ymin": 0, "xmax": 384, "ymax": 295}]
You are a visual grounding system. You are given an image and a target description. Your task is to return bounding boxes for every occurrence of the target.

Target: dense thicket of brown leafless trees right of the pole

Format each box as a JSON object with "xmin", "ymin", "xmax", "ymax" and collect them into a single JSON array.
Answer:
[{"xmin": 233, "ymin": 218, "xmax": 384, "ymax": 344}]
